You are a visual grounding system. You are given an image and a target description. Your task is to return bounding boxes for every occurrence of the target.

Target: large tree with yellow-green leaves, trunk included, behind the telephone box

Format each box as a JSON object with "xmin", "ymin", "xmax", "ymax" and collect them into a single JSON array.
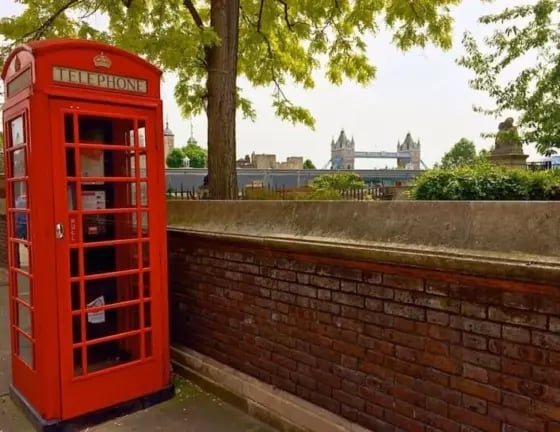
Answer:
[{"xmin": 0, "ymin": 0, "xmax": 460, "ymax": 199}]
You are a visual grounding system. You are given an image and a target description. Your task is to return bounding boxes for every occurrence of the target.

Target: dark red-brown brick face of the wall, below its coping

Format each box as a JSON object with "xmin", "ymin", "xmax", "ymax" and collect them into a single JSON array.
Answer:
[{"xmin": 169, "ymin": 232, "xmax": 560, "ymax": 432}]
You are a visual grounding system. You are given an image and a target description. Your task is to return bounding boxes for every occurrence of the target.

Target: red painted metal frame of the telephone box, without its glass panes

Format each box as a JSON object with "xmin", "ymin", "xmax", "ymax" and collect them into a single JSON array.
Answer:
[{"xmin": 2, "ymin": 40, "xmax": 170, "ymax": 420}]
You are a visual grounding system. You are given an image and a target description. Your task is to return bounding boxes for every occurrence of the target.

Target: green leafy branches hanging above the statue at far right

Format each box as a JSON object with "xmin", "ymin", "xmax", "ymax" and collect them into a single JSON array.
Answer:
[{"xmin": 459, "ymin": 0, "xmax": 560, "ymax": 155}]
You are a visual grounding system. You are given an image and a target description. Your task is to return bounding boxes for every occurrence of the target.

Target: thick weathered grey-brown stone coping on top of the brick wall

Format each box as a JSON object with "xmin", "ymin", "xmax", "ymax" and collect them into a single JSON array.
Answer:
[{"xmin": 168, "ymin": 200, "xmax": 560, "ymax": 285}]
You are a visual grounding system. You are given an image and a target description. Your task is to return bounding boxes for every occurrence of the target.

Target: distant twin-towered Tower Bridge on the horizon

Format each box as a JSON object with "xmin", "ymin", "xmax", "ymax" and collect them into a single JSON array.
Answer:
[{"xmin": 324, "ymin": 129, "xmax": 427, "ymax": 170}]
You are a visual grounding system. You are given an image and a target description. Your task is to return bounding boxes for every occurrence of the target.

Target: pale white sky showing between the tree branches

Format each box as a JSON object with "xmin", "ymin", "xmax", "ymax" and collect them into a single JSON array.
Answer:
[{"xmin": 0, "ymin": 0, "xmax": 539, "ymax": 169}]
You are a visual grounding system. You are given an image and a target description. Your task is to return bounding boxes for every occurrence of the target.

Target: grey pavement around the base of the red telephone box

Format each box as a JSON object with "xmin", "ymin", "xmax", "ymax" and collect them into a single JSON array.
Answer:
[{"xmin": 0, "ymin": 269, "xmax": 274, "ymax": 432}]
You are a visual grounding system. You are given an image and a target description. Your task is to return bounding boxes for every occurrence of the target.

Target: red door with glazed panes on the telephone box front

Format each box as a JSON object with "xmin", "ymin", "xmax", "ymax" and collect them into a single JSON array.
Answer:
[{"xmin": 50, "ymin": 100, "xmax": 167, "ymax": 418}]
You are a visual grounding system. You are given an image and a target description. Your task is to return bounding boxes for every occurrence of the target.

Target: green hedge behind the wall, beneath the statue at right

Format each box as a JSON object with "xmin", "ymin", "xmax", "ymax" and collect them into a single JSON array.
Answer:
[{"xmin": 410, "ymin": 164, "xmax": 560, "ymax": 201}]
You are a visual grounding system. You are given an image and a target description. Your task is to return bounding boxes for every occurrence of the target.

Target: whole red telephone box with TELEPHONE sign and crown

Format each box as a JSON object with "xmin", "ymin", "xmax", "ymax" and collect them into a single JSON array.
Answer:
[{"xmin": 2, "ymin": 39, "xmax": 173, "ymax": 429}]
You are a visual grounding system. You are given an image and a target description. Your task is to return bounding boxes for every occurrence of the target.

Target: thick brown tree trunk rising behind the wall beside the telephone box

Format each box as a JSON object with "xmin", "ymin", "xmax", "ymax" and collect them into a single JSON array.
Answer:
[{"xmin": 206, "ymin": 0, "xmax": 239, "ymax": 199}]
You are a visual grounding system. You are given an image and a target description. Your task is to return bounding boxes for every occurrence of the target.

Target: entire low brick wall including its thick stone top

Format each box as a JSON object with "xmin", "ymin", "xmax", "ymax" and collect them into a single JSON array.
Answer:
[{"xmin": 169, "ymin": 202, "xmax": 560, "ymax": 432}]
